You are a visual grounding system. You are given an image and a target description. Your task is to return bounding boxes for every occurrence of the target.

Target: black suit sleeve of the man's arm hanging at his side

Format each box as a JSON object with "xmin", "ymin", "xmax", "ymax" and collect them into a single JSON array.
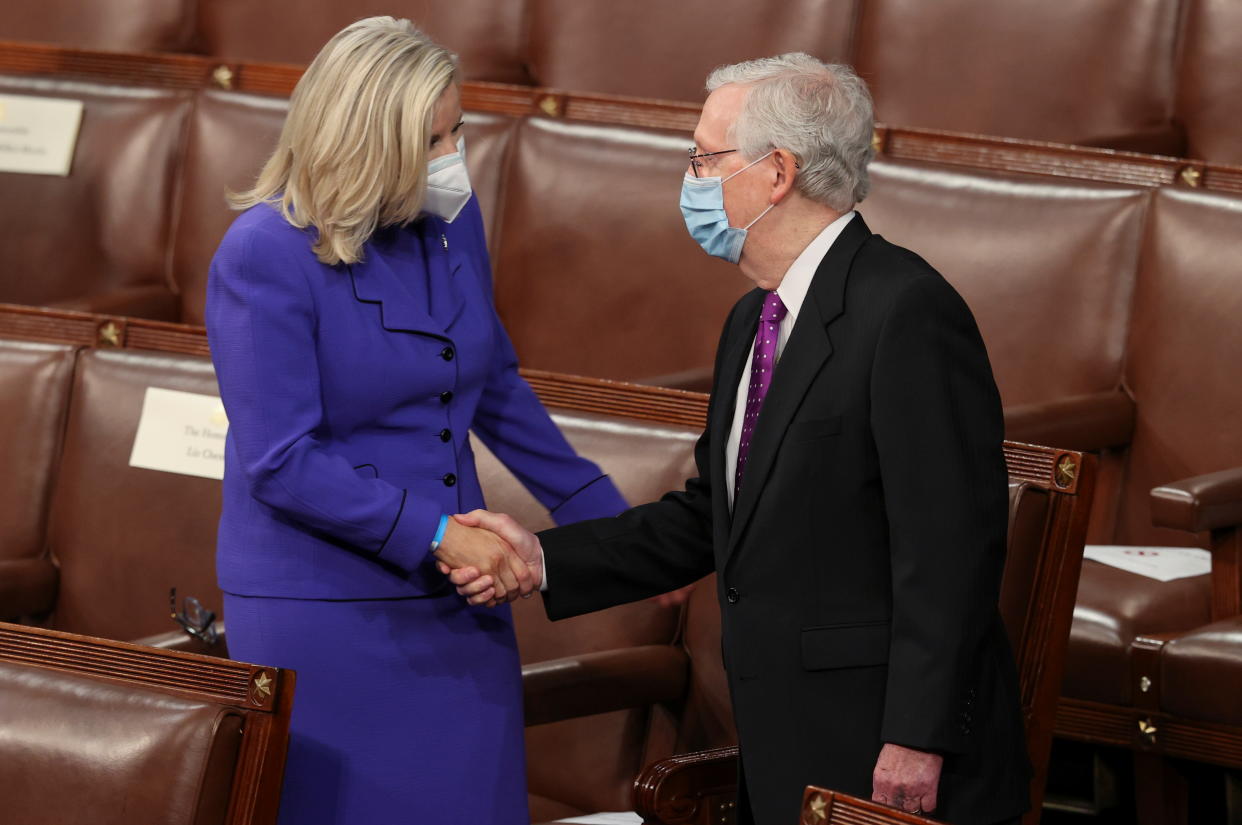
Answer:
[{"xmin": 871, "ymin": 276, "xmax": 1009, "ymax": 753}]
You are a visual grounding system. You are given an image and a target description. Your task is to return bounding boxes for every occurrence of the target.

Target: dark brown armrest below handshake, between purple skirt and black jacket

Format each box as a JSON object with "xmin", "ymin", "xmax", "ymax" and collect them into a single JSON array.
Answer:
[{"xmin": 522, "ymin": 645, "xmax": 689, "ymax": 726}]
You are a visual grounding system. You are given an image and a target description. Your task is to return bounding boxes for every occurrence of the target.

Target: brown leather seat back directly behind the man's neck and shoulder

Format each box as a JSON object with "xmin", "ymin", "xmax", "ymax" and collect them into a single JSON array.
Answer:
[{"xmin": 858, "ymin": 160, "xmax": 1149, "ymax": 407}]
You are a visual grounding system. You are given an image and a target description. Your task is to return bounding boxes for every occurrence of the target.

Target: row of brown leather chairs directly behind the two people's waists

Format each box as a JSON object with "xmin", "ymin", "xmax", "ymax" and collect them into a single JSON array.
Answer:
[{"xmin": 0, "ymin": 308, "xmax": 1094, "ymax": 821}]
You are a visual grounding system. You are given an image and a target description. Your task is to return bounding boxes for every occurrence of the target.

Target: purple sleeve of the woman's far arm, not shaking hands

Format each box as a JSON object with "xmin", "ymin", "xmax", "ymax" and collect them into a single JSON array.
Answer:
[{"xmin": 462, "ymin": 199, "xmax": 628, "ymax": 524}]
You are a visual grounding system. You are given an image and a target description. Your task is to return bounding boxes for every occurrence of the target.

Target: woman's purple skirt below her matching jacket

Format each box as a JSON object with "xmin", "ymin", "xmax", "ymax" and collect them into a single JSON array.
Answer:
[{"xmin": 224, "ymin": 591, "xmax": 530, "ymax": 825}]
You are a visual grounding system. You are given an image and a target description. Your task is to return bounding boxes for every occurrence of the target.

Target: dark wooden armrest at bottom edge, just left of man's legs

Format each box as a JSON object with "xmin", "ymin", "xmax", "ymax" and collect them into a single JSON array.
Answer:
[{"xmin": 633, "ymin": 748, "xmax": 738, "ymax": 825}]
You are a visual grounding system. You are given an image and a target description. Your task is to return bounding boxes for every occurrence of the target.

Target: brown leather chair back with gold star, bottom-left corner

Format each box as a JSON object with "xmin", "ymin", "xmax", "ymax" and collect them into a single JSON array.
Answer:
[{"xmin": 0, "ymin": 624, "xmax": 294, "ymax": 825}]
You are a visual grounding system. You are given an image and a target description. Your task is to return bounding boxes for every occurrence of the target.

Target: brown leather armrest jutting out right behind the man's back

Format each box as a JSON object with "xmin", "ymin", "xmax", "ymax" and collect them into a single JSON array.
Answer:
[{"xmin": 1005, "ymin": 390, "xmax": 1134, "ymax": 450}]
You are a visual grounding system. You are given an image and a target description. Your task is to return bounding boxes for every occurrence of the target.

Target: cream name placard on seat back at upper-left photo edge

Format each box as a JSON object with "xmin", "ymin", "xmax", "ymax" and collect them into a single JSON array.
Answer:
[{"xmin": 0, "ymin": 94, "xmax": 82, "ymax": 176}]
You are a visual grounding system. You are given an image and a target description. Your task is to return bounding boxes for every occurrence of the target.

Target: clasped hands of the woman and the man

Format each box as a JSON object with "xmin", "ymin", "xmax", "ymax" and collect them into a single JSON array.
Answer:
[{"xmin": 435, "ymin": 509, "xmax": 544, "ymax": 608}]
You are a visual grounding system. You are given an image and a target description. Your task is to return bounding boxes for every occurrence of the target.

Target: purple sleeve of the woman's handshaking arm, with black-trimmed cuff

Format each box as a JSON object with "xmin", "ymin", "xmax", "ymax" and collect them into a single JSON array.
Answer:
[{"xmin": 206, "ymin": 222, "xmax": 441, "ymax": 570}]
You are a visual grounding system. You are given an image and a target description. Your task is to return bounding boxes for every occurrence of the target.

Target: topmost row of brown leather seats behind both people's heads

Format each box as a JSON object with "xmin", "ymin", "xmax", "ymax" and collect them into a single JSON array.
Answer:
[{"xmin": 0, "ymin": 0, "xmax": 1242, "ymax": 163}]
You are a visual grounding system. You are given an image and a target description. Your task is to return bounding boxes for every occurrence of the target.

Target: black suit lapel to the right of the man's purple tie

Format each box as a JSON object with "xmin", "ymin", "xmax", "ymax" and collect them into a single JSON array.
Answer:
[{"xmin": 725, "ymin": 215, "xmax": 871, "ymax": 558}]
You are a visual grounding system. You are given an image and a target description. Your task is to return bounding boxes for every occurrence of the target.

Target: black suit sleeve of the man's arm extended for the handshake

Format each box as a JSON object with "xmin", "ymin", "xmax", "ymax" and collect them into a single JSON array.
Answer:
[{"xmin": 539, "ymin": 299, "xmax": 737, "ymax": 620}]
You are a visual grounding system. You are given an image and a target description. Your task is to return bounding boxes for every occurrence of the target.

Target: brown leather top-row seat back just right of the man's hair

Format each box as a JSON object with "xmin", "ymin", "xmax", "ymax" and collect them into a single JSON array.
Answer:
[{"xmin": 854, "ymin": 0, "xmax": 1180, "ymax": 154}]
